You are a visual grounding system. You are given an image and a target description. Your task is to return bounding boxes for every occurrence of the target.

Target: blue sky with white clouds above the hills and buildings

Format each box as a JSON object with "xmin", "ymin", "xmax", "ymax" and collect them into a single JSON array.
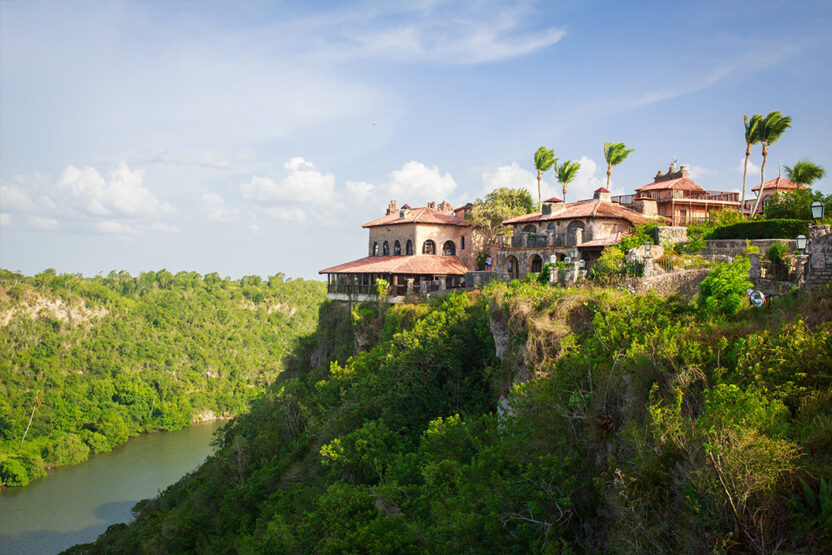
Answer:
[{"xmin": 0, "ymin": 0, "xmax": 832, "ymax": 279}]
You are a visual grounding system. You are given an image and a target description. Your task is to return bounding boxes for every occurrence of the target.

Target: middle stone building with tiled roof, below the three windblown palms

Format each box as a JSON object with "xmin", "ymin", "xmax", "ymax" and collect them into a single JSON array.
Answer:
[{"xmin": 497, "ymin": 187, "xmax": 657, "ymax": 278}]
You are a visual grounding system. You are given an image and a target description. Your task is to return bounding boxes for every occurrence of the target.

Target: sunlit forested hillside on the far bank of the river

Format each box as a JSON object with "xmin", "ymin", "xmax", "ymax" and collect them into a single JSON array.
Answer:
[{"xmin": 0, "ymin": 270, "xmax": 324, "ymax": 486}]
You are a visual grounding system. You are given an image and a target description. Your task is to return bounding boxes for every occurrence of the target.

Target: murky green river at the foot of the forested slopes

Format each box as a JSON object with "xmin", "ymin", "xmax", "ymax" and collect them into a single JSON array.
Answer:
[{"xmin": 0, "ymin": 422, "xmax": 221, "ymax": 555}]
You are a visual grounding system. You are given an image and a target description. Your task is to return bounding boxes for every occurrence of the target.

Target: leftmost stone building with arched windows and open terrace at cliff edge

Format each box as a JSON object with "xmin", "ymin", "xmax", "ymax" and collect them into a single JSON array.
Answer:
[{"xmin": 318, "ymin": 200, "xmax": 481, "ymax": 301}]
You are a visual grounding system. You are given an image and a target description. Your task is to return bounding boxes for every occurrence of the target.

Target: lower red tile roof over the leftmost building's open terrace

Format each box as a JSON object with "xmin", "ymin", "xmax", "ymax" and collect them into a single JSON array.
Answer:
[{"xmin": 318, "ymin": 254, "xmax": 468, "ymax": 276}]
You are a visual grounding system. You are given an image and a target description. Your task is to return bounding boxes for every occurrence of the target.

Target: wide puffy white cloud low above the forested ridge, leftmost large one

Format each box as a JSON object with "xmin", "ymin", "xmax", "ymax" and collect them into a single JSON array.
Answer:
[{"xmin": 57, "ymin": 164, "xmax": 176, "ymax": 218}]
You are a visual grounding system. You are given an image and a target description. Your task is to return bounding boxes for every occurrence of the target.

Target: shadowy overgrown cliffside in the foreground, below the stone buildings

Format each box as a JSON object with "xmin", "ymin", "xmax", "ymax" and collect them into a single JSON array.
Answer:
[{"xmin": 73, "ymin": 272, "xmax": 832, "ymax": 553}]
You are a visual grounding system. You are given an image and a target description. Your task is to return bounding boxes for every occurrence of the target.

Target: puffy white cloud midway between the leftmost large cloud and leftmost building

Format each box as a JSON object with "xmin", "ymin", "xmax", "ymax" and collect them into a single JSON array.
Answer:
[{"xmin": 240, "ymin": 156, "xmax": 335, "ymax": 205}]
